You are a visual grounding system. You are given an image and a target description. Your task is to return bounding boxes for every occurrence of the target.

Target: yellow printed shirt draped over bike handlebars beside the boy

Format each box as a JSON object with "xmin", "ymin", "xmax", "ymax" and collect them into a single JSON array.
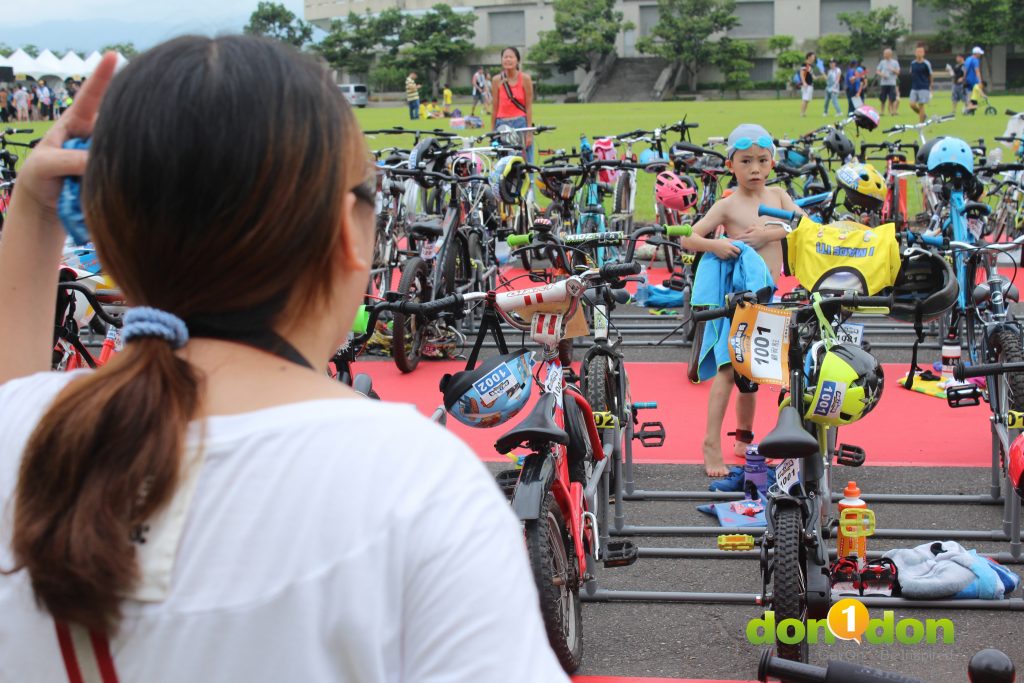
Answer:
[{"xmin": 782, "ymin": 216, "xmax": 900, "ymax": 296}]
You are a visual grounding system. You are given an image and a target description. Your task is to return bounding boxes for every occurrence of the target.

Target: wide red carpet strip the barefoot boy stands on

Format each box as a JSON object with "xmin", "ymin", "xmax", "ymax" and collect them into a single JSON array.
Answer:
[{"xmin": 356, "ymin": 360, "xmax": 991, "ymax": 467}]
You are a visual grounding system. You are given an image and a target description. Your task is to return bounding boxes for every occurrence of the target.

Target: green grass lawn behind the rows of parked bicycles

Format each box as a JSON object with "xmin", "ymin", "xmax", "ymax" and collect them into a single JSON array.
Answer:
[{"xmin": 356, "ymin": 92, "xmax": 1024, "ymax": 220}]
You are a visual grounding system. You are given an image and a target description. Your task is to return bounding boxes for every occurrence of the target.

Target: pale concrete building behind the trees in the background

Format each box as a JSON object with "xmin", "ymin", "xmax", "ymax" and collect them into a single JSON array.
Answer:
[{"xmin": 305, "ymin": 0, "xmax": 1008, "ymax": 92}]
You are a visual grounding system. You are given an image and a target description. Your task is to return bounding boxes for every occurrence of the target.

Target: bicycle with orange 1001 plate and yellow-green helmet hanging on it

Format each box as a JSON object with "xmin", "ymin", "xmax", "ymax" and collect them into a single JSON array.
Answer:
[{"xmin": 693, "ymin": 286, "xmax": 894, "ymax": 661}]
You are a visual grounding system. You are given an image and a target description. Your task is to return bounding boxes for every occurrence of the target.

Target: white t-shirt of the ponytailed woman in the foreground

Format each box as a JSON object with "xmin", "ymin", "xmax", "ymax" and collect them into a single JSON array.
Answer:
[{"xmin": 0, "ymin": 373, "xmax": 568, "ymax": 683}]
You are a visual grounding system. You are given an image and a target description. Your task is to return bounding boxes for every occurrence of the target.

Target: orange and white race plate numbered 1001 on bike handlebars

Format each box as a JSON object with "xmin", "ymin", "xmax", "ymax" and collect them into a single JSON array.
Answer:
[{"xmin": 729, "ymin": 304, "xmax": 790, "ymax": 386}]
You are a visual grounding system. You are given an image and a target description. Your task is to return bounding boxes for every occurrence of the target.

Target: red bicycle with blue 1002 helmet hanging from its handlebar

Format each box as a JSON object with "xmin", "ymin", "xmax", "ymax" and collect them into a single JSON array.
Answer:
[{"xmin": 391, "ymin": 263, "xmax": 639, "ymax": 673}]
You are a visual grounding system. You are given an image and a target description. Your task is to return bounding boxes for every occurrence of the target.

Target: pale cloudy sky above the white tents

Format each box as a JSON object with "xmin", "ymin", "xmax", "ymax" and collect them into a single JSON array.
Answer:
[{"xmin": 0, "ymin": 0, "xmax": 304, "ymax": 54}]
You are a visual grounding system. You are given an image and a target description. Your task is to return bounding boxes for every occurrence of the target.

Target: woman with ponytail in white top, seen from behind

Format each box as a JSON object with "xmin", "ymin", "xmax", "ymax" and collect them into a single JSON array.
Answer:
[{"xmin": 0, "ymin": 36, "xmax": 565, "ymax": 683}]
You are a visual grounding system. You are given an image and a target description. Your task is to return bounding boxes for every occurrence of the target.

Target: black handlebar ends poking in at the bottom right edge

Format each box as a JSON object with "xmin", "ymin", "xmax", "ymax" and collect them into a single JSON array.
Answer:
[{"xmin": 758, "ymin": 648, "xmax": 1016, "ymax": 683}]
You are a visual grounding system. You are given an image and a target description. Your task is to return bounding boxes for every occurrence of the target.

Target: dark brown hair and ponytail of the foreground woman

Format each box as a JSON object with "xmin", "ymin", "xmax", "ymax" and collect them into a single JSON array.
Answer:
[{"xmin": 12, "ymin": 36, "xmax": 367, "ymax": 631}]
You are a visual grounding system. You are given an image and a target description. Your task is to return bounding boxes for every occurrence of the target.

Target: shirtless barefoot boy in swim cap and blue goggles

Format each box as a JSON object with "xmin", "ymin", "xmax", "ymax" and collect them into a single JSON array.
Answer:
[{"xmin": 686, "ymin": 124, "xmax": 803, "ymax": 477}]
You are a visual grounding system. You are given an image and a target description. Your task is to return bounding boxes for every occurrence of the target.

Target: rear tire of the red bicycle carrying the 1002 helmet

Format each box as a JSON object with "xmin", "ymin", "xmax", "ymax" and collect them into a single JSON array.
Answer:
[{"xmin": 524, "ymin": 490, "xmax": 583, "ymax": 674}]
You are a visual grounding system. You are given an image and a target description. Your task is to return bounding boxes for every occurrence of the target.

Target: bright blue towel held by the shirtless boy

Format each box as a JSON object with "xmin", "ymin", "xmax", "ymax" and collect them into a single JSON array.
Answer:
[{"xmin": 690, "ymin": 242, "xmax": 775, "ymax": 382}]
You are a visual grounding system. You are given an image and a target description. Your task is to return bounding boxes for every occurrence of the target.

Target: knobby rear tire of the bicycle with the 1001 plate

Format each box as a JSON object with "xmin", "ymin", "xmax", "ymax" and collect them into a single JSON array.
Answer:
[{"xmin": 771, "ymin": 506, "xmax": 807, "ymax": 661}]
